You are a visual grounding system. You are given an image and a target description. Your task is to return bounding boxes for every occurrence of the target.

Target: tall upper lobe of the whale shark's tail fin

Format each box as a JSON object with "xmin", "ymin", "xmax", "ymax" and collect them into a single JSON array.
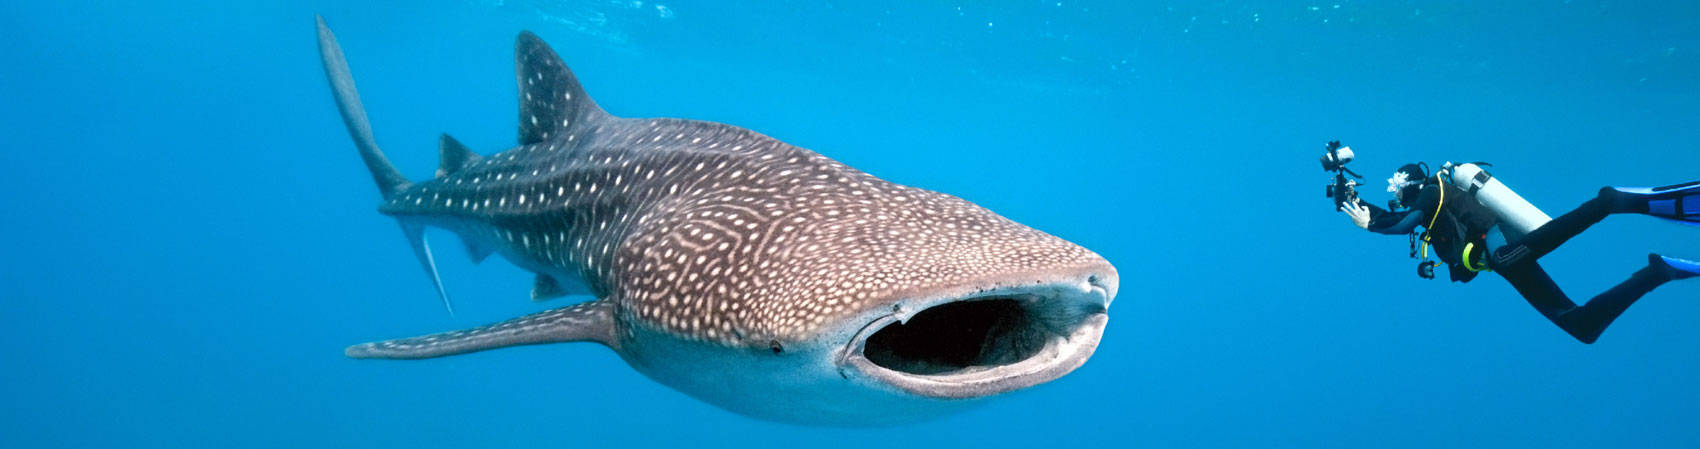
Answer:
[{"xmin": 313, "ymin": 15, "xmax": 411, "ymax": 199}]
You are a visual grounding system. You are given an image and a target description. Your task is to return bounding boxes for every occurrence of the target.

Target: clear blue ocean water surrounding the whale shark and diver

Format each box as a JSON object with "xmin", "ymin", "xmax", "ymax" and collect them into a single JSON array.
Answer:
[{"xmin": 0, "ymin": 0, "xmax": 1700, "ymax": 447}]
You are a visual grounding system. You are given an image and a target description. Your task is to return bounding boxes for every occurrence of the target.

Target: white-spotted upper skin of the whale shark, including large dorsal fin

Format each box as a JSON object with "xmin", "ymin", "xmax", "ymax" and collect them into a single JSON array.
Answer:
[{"xmin": 365, "ymin": 32, "xmax": 1100, "ymax": 347}]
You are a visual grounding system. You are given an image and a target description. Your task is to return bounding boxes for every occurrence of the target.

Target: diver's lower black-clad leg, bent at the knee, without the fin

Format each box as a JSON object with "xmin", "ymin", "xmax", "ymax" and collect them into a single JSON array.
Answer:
[{"xmin": 1499, "ymin": 260, "xmax": 1671, "ymax": 344}]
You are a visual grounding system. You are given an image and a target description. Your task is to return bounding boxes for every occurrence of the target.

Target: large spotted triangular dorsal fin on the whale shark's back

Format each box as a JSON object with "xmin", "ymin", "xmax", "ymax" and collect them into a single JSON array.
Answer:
[{"xmin": 513, "ymin": 31, "xmax": 607, "ymax": 145}]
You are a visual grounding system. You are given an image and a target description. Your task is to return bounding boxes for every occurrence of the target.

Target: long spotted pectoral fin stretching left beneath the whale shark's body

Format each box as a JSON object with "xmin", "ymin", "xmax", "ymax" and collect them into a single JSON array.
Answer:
[{"xmin": 343, "ymin": 299, "xmax": 614, "ymax": 359}]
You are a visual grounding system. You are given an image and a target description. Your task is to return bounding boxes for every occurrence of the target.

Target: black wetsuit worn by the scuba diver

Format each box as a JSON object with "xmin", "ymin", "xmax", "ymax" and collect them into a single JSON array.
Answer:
[{"xmin": 1365, "ymin": 184, "xmax": 1671, "ymax": 344}]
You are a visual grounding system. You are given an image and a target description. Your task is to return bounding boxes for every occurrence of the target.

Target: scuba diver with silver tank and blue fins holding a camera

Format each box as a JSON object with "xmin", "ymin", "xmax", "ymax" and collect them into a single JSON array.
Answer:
[{"xmin": 1323, "ymin": 141, "xmax": 1700, "ymax": 344}]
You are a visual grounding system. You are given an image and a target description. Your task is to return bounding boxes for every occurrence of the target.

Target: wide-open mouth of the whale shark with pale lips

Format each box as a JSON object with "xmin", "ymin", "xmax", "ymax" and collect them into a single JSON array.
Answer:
[{"xmin": 843, "ymin": 279, "xmax": 1110, "ymax": 400}]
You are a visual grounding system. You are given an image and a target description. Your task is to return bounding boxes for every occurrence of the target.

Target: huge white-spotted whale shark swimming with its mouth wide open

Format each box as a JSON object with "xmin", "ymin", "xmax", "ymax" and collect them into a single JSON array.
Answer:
[{"xmin": 316, "ymin": 17, "xmax": 1119, "ymax": 425}]
